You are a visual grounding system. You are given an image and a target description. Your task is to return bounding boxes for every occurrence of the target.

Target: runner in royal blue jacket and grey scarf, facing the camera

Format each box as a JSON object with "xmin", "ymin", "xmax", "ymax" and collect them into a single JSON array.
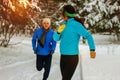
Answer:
[{"xmin": 32, "ymin": 18, "xmax": 56, "ymax": 80}]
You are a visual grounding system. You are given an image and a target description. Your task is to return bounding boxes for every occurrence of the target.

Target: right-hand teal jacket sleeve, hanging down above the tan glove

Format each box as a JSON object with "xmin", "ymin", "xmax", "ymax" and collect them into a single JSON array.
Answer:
[{"xmin": 76, "ymin": 24, "xmax": 95, "ymax": 50}]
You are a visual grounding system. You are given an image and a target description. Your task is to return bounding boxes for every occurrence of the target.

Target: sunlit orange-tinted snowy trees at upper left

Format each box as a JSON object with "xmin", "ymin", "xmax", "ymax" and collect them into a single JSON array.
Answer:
[{"xmin": 0, "ymin": 0, "xmax": 58, "ymax": 46}]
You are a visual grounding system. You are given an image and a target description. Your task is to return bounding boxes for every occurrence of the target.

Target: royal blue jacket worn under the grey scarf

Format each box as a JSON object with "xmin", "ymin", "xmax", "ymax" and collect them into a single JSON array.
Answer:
[{"xmin": 32, "ymin": 28, "xmax": 56, "ymax": 55}]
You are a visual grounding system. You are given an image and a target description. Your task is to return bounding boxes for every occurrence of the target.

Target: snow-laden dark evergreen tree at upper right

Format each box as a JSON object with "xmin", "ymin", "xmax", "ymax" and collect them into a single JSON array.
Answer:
[{"xmin": 64, "ymin": 0, "xmax": 120, "ymax": 39}]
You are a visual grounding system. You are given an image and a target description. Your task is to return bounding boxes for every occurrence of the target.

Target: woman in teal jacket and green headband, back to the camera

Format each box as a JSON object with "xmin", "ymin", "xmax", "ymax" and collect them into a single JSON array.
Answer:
[{"xmin": 53, "ymin": 5, "xmax": 95, "ymax": 80}]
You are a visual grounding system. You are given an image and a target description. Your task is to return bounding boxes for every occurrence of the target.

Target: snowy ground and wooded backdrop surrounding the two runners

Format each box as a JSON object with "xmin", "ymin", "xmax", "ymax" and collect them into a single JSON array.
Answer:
[{"xmin": 0, "ymin": 0, "xmax": 120, "ymax": 80}]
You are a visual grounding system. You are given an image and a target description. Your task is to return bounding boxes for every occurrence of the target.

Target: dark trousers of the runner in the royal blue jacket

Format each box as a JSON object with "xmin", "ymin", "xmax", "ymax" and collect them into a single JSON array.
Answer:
[{"xmin": 36, "ymin": 55, "xmax": 52, "ymax": 80}]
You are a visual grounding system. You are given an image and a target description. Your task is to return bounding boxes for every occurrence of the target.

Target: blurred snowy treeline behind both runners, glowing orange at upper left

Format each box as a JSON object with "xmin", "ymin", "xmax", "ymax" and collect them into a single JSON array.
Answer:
[{"xmin": 0, "ymin": 0, "xmax": 120, "ymax": 47}]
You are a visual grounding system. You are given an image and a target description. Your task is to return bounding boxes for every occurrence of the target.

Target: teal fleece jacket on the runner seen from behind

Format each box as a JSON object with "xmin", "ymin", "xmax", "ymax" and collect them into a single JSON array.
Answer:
[{"xmin": 53, "ymin": 18, "xmax": 95, "ymax": 55}]
